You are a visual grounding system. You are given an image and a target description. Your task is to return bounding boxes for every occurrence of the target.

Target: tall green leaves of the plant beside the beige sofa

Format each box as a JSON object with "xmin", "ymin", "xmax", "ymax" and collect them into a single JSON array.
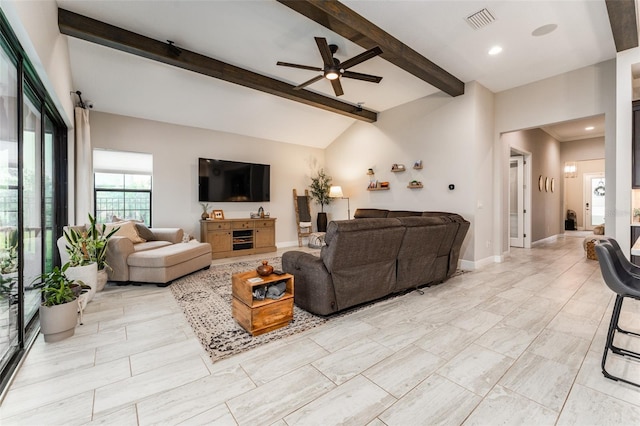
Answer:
[{"xmin": 63, "ymin": 214, "xmax": 120, "ymax": 270}]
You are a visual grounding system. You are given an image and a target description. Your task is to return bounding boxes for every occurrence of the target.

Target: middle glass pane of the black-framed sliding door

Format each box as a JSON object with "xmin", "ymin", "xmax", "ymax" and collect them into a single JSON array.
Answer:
[{"xmin": 22, "ymin": 96, "xmax": 42, "ymax": 324}]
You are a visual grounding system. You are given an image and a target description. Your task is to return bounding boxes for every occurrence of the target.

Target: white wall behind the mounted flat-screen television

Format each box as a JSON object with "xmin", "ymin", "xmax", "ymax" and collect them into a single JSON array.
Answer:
[{"xmin": 90, "ymin": 111, "xmax": 324, "ymax": 247}]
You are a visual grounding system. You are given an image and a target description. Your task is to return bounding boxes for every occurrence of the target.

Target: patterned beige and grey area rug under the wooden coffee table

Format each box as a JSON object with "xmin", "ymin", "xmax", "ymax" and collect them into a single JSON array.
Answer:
[{"xmin": 170, "ymin": 257, "xmax": 327, "ymax": 362}]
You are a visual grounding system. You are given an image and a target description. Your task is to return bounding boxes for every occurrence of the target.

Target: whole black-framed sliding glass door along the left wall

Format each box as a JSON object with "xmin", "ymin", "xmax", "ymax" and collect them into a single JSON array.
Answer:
[{"xmin": 0, "ymin": 10, "xmax": 67, "ymax": 392}]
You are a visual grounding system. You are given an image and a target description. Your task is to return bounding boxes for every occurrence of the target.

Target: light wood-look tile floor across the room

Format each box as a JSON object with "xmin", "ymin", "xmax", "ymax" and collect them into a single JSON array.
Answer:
[{"xmin": 0, "ymin": 237, "xmax": 640, "ymax": 425}]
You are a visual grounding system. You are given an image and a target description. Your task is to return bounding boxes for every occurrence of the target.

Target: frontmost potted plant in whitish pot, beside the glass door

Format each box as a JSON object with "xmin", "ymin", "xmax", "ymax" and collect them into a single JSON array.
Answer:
[{"xmin": 34, "ymin": 263, "xmax": 82, "ymax": 342}]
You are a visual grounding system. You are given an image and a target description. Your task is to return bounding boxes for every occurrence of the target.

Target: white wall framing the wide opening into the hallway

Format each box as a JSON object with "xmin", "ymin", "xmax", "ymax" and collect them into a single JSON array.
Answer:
[{"xmin": 494, "ymin": 60, "xmax": 616, "ymax": 255}]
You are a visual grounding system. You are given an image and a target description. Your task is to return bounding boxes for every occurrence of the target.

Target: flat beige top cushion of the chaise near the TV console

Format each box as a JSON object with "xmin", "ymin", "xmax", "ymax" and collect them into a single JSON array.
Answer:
[{"xmin": 127, "ymin": 241, "xmax": 211, "ymax": 268}]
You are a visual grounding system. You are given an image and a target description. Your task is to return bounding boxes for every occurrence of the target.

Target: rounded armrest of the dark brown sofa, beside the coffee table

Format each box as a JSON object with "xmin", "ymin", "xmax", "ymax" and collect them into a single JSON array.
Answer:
[{"xmin": 282, "ymin": 251, "xmax": 338, "ymax": 315}]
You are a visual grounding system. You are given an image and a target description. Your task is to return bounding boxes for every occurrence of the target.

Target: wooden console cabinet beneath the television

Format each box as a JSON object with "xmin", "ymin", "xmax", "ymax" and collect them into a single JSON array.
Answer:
[{"xmin": 200, "ymin": 218, "xmax": 276, "ymax": 259}]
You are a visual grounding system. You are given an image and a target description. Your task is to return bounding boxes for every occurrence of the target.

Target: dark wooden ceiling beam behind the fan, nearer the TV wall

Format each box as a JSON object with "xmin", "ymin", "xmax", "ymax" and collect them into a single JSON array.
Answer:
[{"xmin": 58, "ymin": 9, "xmax": 378, "ymax": 123}]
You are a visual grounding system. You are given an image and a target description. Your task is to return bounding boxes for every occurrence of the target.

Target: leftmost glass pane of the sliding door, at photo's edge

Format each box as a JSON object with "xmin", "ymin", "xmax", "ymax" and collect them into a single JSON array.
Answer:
[{"xmin": 0, "ymin": 43, "xmax": 19, "ymax": 369}]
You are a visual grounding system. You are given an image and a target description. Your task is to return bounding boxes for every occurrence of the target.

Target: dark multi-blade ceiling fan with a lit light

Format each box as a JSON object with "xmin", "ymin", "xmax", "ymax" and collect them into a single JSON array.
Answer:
[{"xmin": 277, "ymin": 37, "xmax": 382, "ymax": 96}]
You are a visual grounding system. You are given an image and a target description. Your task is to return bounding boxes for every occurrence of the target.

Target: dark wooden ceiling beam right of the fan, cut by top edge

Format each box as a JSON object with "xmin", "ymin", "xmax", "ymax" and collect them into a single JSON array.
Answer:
[{"xmin": 277, "ymin": 0, "xmax": 464, "ymax": 96}]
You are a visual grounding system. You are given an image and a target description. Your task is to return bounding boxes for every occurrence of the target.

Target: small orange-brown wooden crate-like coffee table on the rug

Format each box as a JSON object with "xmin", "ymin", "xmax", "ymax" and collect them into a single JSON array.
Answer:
[{"xmin": 231, "ymin": 271, "xmax": 293, "ymax": 336}]
